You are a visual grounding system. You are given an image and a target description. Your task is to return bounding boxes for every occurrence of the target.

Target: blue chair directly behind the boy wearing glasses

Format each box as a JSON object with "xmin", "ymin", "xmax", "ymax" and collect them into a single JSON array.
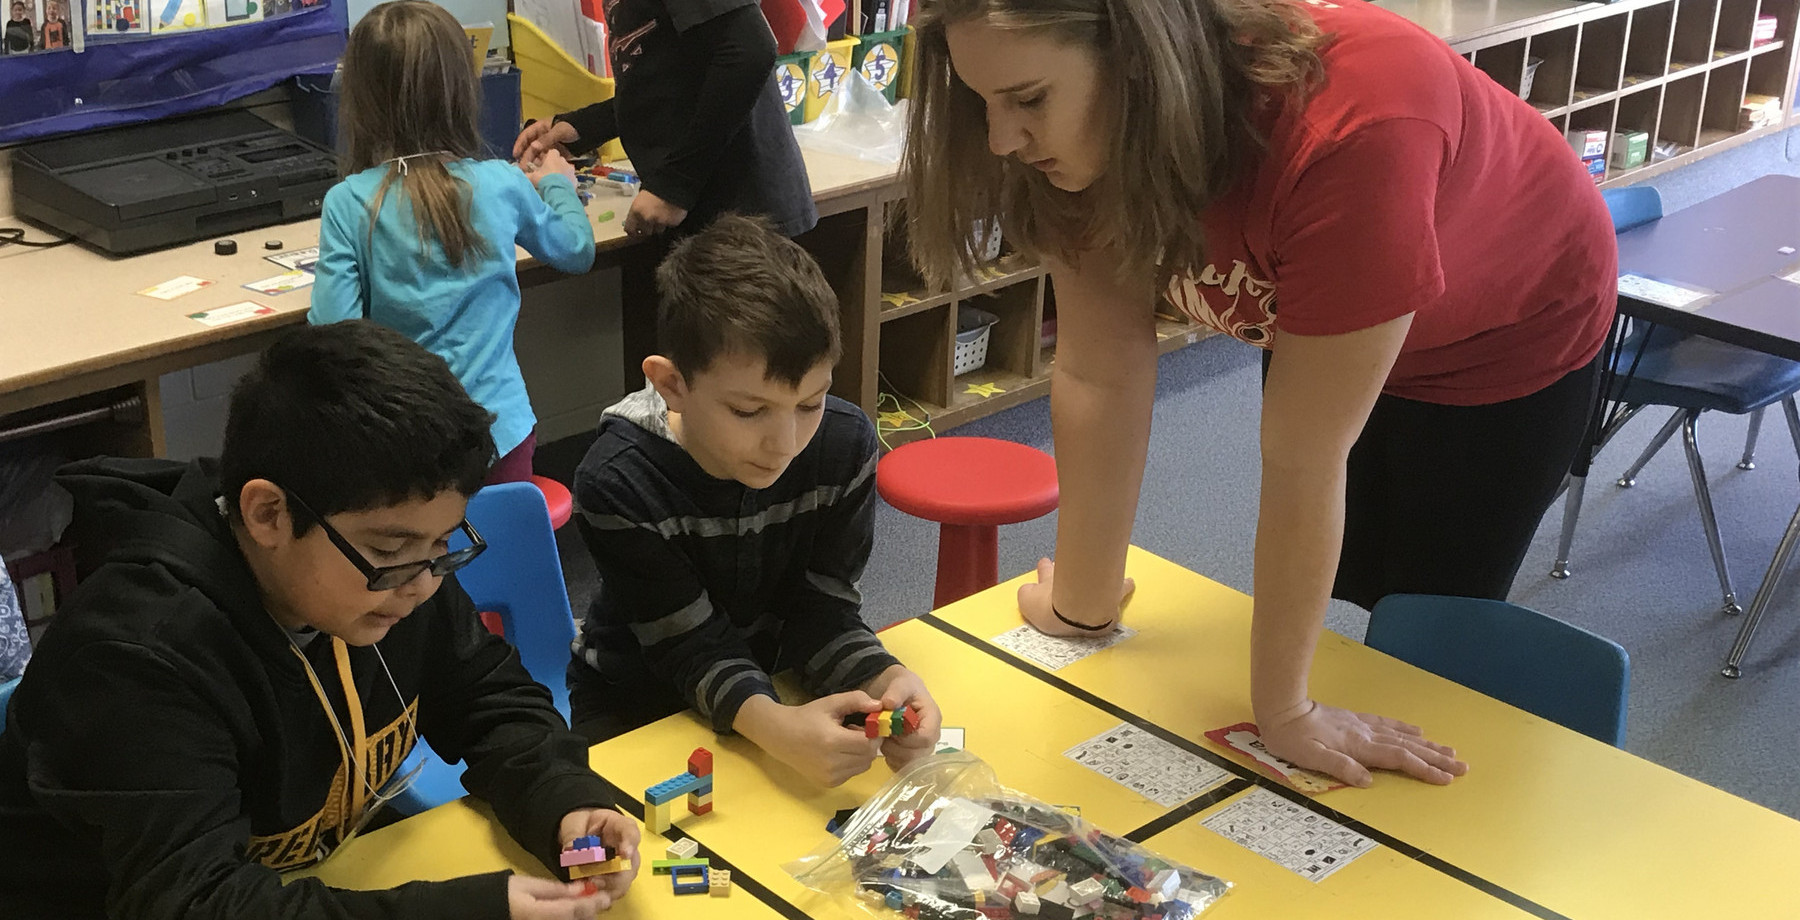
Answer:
[{"xmin": 392, "ymin": 483, "xmax": 574, "ymax": 814}]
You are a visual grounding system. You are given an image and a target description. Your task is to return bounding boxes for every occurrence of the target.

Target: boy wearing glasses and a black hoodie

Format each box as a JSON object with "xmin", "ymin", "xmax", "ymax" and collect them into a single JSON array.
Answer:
[{"xmin": 0, "ymin": 320, "xmax": 637, "ymax": 920}]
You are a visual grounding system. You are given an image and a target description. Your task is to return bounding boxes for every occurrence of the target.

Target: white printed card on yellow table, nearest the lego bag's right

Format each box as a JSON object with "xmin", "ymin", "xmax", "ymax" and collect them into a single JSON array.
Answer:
[{"xmin": 1201, "ymin": 789, "xmax": 1381, "ymax": 882}]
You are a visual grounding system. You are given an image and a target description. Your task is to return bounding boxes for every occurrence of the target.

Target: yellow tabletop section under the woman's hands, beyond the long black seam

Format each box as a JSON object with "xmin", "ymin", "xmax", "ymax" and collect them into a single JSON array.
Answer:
[{"xmin": 927, "ymin": 547, "xmax": 1800, "ymax": 920}]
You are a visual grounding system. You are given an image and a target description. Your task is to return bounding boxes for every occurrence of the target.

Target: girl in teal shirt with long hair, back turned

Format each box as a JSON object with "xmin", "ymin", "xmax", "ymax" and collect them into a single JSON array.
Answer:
[{"xmin": 308, "ymin": 0, "xmax": 594, "ymax": 483}]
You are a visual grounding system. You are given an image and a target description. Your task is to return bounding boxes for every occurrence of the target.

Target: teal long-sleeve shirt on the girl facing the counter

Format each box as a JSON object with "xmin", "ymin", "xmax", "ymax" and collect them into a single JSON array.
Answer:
[{"xmin": 306, "ymin": 160, "xmax": 594, "ymax": 455}]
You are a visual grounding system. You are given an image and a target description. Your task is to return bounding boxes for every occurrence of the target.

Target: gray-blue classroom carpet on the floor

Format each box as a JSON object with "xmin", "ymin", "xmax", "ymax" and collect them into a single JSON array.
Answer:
[{"xmin": 538, "ymin": 131, "xmax": 1800, "ymax": 817}]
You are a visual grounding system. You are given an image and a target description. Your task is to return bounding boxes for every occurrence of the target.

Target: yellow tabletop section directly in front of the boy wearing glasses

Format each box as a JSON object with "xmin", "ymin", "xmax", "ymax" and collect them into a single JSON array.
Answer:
[{"xmin": 288, "ymin": 798, "xmax": 781, "ymax": 920}]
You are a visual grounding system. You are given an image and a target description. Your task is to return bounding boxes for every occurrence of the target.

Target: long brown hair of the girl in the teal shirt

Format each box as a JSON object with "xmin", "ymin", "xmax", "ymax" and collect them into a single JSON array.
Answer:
[{"xmin": 338, "ymin": 0, "xmax": 490, "ymax": 268}]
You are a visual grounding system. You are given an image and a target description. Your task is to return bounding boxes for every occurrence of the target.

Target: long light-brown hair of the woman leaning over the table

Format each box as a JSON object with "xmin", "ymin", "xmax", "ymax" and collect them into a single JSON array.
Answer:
[{"xmin": 904, "ymin": 0, "xmax": 1325, "ymax": 286}]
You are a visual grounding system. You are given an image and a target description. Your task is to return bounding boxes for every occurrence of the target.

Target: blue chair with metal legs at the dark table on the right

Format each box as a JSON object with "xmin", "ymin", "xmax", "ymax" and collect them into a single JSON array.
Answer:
[{"xmin": 1550, "ymin": 185, "xmax": 1800, "ymax": 616}]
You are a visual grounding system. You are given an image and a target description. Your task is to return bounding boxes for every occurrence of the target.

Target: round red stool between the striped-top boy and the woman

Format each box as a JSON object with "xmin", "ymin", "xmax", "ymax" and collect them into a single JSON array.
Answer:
[{"xmin": 875, "ymin": 437, "xmax": 1057, "ymax": 609}]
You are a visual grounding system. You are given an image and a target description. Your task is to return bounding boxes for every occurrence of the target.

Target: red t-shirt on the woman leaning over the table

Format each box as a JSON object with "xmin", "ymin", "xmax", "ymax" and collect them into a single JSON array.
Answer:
[{"xmin": 1163, "ymin": 0, "xmax": 1618, "ymax": 405}]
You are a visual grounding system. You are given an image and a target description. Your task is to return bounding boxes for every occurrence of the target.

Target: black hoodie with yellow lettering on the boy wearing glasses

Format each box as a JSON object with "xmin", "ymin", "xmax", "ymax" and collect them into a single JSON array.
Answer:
[{"xmin": 0, "ymin": 459, "xmax": 610, "ymax": 920}]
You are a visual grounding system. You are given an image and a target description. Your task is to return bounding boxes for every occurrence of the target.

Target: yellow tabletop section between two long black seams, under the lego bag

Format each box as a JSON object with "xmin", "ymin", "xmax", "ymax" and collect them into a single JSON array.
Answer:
[{"xmin": 590, "ymin": 619, "xmax": 1562, "ymax": 920}]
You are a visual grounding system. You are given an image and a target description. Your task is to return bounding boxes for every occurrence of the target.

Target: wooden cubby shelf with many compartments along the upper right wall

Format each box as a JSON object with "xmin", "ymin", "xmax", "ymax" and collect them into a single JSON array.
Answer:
[{"xmin": 1440, "ymin": 0, "xmax": 1800, "ymax": 187}]
